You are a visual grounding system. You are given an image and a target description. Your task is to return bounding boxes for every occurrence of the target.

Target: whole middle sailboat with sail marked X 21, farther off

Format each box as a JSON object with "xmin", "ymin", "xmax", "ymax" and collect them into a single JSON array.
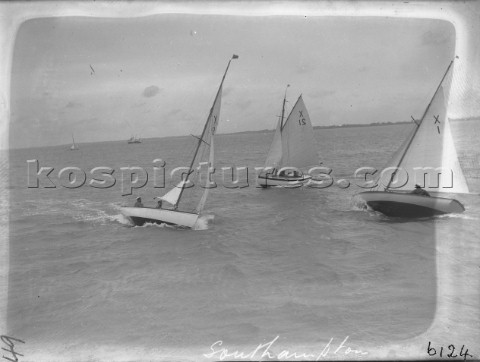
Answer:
[{"xmin": 257, "ymin": 85, "xmax": 318, "ymax": 187}]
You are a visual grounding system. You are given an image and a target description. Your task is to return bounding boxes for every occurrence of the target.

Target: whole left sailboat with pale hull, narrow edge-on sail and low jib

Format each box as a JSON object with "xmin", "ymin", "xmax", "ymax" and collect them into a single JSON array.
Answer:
[{"xmin": 121, "ymin": 55, "xmax": 238, "ymax": 228}]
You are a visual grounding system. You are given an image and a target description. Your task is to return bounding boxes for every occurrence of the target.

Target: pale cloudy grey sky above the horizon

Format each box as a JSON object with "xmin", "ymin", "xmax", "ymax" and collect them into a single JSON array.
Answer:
[{"xmin": 10, "ymin": 14, "xmax": 455, "ymax": 148}]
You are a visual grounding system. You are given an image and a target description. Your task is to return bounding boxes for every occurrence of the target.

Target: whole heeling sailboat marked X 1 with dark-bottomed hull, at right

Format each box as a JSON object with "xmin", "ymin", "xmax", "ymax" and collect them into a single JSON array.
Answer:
[{"xmin": 357, "ymin": 61, "xmax": 469, "ymax": 218}]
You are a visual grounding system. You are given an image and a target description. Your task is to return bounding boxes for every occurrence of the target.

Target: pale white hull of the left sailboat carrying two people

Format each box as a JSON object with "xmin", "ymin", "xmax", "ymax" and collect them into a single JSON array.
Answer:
[{"xmin": 120, "ymin": 207, "xmax": 198, "ymax": 228}]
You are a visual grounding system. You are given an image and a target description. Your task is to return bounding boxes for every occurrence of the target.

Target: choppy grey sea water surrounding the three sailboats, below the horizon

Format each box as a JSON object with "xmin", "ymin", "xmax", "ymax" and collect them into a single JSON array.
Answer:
[{"xmin": 4, "ymin": 122, "xmax": 480, "ymax": 360}]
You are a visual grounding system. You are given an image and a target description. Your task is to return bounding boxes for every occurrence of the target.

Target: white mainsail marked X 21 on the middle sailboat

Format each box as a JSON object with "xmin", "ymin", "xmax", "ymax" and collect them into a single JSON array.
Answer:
[{"xmin": 281, "ymin": 96, "xmax": 318, "ymax": 168}]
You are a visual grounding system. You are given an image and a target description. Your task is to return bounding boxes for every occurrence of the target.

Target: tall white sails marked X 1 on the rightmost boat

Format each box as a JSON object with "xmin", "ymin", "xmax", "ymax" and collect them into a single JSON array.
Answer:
[{"xmin": 380, "ymin": 61, "xmax": 468, "ymax": 193}]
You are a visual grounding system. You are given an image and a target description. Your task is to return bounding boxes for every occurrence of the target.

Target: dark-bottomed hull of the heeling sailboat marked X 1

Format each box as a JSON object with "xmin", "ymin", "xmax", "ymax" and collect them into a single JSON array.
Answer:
[{"xmin": 358, "ymin": 191, "xmax": 465, "ymax": 218}]
